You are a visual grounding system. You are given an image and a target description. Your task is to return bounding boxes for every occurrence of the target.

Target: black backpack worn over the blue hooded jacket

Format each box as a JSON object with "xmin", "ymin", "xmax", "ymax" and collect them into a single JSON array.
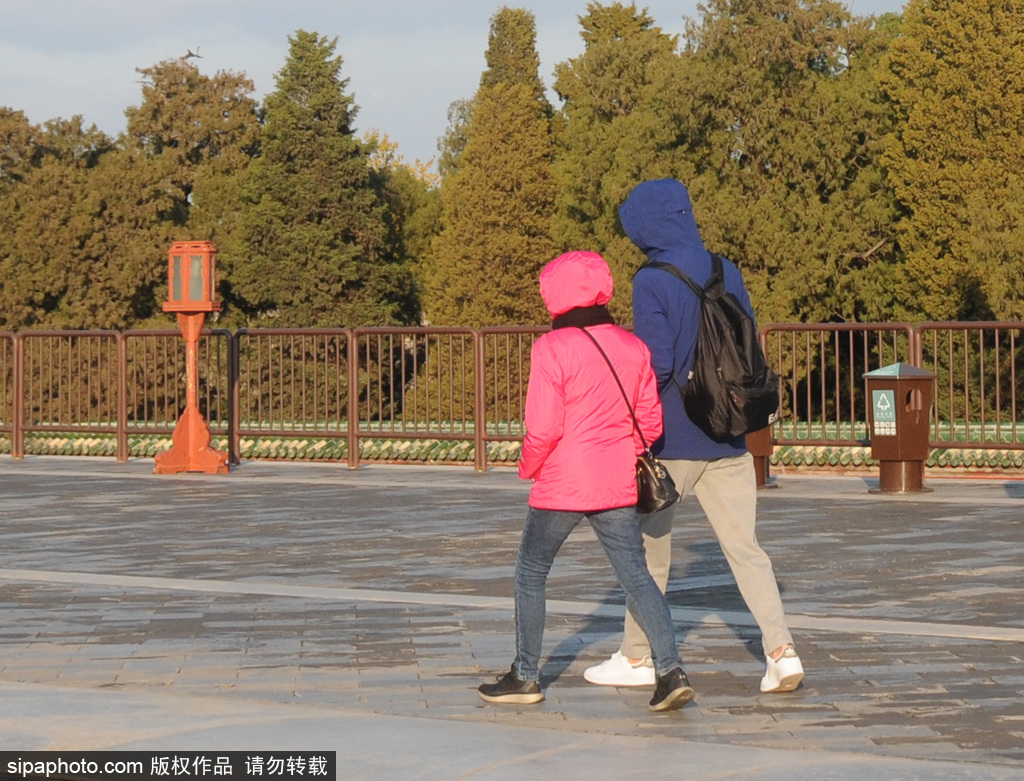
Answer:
[{"xmin": 641, "ymin": 254, "xmax": 779, "ymax": 442}]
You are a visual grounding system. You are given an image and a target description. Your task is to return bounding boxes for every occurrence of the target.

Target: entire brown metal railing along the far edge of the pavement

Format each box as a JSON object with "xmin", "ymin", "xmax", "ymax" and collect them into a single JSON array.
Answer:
[{"xmin": 0, "ymin": 322, "xmax": 1024, "ymax": 470}]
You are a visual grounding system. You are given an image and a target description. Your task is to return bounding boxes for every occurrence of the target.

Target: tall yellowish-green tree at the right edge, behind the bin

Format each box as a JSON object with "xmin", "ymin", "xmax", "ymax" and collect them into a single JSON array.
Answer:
[{"xmin": 884, "ymin": 0, "xmax": 1024, "ymax": 320}]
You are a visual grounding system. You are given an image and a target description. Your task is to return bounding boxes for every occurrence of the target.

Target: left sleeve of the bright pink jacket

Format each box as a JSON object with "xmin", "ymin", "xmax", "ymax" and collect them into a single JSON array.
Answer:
[{"xmin": 519, "ymin": 339, "xmax": 569, "ymax": 480}]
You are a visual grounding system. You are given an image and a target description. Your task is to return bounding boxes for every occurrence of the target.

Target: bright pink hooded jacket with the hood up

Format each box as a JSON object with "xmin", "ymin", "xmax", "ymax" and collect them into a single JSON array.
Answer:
[{"xmin": 519, "ymin": 252, "xmax": 662, "ymax": 512}]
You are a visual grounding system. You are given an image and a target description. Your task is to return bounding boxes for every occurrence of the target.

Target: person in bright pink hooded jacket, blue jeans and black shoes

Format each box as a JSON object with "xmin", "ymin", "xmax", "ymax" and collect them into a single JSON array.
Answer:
[{"xmin": 477, "ymin": 252, "xmax": 693, "ymax": 710}]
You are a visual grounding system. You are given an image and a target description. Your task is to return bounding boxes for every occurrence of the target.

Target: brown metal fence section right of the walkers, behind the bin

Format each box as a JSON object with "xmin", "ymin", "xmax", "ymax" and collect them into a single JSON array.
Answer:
[{"xmin": 762, "ymin": 322, "xmax": 1024, "ymax": 450}]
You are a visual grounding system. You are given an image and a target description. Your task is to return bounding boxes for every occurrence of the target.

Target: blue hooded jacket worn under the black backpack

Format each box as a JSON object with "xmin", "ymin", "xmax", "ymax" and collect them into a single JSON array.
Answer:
[{"xmin": 618, "ymin": 179, "xmax": 753, "ymax": 461}]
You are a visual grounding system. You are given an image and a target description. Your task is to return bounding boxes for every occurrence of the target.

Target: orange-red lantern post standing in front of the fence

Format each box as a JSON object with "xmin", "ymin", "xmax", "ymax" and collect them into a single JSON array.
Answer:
[{"xmin": 153, "ymin": 242, "xmax": 228, "ymax": 475}]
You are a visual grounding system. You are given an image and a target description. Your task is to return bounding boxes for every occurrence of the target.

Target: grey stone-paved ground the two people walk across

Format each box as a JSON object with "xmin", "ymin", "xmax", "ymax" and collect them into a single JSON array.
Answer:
[{"xmin": 0, "ymin": 457, "xmax": 1024, "ymax": 781}]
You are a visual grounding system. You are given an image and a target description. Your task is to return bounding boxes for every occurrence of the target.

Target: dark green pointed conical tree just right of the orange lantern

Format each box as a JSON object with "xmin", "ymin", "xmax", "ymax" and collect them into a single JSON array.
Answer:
[{"xmin": 230, "ymin": 30, "xmax": 416, "ymax": 327}]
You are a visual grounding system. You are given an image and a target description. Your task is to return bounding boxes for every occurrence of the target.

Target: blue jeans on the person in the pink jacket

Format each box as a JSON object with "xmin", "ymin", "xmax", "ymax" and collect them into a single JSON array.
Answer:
[{"xmin": 514, "ymin": 507, "xmax": 683, "ymax": 681}]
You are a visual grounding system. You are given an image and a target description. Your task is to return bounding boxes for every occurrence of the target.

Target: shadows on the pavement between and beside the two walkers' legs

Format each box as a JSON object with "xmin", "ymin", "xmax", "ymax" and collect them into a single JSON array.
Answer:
[{"xmin": 541, "ymin": 535, "xmax": 784, "ymax": 686}]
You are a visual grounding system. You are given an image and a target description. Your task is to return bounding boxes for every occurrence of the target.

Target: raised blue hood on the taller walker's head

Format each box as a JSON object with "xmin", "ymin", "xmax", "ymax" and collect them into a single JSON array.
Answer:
[{"xmin": 618, "ymin": 179, "xmax": 710, "ymax": 267}]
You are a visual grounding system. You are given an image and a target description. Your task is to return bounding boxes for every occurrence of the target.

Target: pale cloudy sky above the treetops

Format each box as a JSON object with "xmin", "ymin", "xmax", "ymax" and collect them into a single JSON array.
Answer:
[{"xmin": 0, "ymin": 0, "xmax": 904, "ymax": 169}]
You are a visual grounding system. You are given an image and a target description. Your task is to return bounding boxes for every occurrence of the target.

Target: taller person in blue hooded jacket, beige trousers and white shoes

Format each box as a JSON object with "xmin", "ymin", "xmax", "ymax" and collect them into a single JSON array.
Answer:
[{"xmin": 584, "ymin": 179, "xmax": 804, "ymax": 692}]
